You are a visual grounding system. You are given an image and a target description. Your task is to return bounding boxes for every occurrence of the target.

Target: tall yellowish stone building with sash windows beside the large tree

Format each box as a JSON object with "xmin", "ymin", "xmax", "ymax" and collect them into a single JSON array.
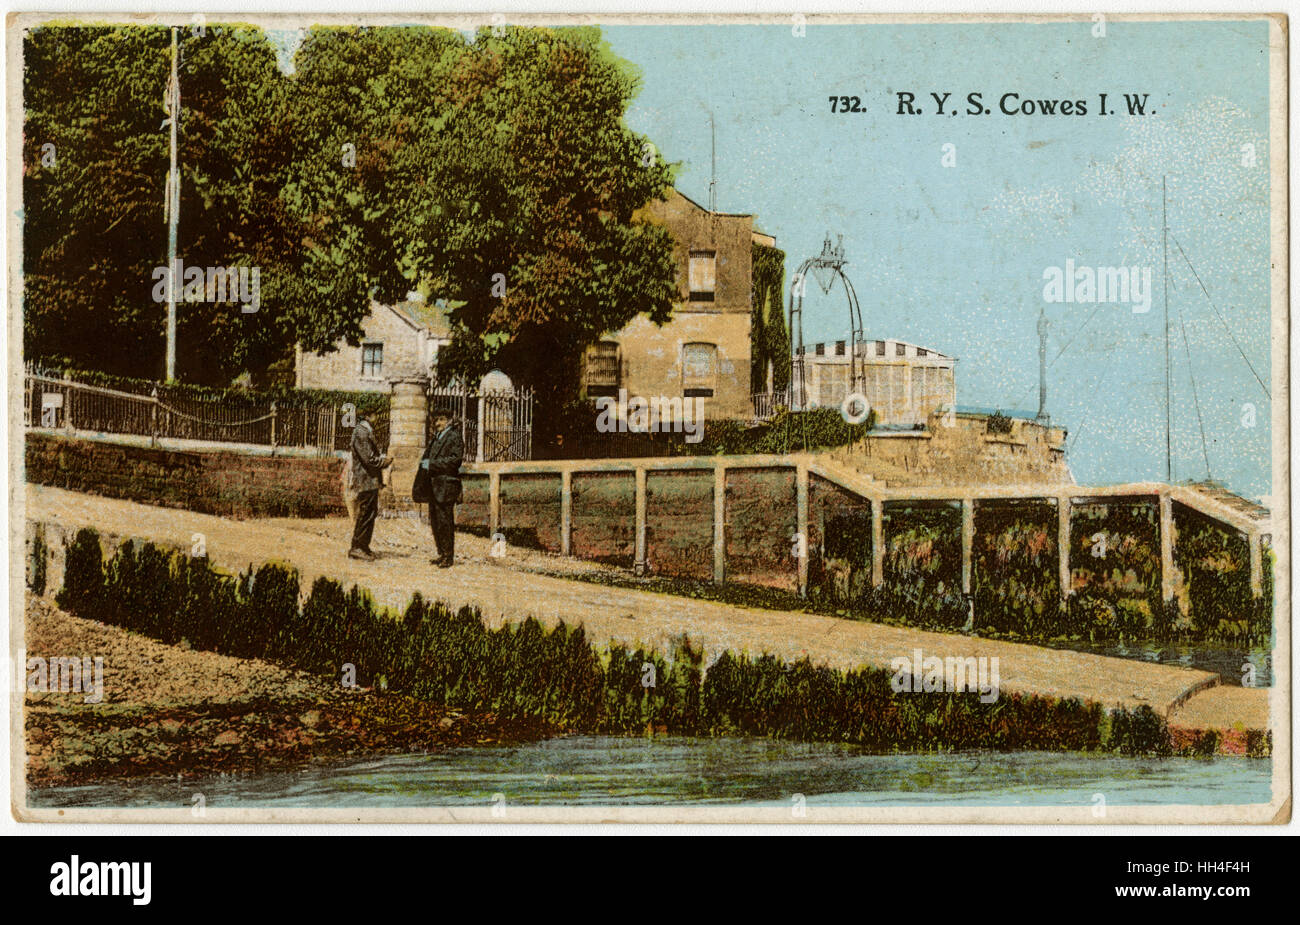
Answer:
[{"xmin": 582, "ymin": 190, "xmax": 776, "ymax": 420}]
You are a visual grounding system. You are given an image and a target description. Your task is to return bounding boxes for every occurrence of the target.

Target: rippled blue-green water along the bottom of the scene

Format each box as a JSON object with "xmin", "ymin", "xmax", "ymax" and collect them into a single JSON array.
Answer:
[{"xmin": 30, "ymin": 737, "xmax": 1271, "ymax": 808}]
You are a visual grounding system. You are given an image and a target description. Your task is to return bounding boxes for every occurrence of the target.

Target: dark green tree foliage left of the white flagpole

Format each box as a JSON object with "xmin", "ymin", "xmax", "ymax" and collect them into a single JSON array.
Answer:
[{"xmin": 22, "ymin": 27, "xmax": 168, "ymax": 373}]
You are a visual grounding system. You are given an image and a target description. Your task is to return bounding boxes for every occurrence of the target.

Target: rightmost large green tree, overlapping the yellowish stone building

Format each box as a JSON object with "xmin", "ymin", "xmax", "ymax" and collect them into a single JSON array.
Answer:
[{"xmin": 417, "ymin": 29, "xmax": 680, "ymax": 403}]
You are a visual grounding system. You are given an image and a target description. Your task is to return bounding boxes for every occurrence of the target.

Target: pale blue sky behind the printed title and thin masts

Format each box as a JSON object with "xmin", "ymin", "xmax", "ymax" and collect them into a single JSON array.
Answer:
[{"xmin": 605, "ymin": 22, "xmax": 1271, "ymax": 498}]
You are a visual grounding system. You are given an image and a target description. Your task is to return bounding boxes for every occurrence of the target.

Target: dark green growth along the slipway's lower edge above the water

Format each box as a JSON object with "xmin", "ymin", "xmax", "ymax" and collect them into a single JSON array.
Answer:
[{"xmin": 56, "ymin": 529, "xmax": 1211, "ymax": 754}]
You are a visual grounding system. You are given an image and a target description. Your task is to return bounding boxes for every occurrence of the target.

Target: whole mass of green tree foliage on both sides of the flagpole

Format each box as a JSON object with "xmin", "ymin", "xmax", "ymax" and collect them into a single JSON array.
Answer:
[{"xmin": 23, "ymin": 25, "xmax": 676, "ymax": 399}]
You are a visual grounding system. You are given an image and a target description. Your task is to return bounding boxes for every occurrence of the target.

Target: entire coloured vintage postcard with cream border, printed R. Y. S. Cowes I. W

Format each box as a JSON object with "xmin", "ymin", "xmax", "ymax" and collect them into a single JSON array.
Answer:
[{"xmin": 7, "ymin": 13, "xmax": 1292, "ymax": 825}]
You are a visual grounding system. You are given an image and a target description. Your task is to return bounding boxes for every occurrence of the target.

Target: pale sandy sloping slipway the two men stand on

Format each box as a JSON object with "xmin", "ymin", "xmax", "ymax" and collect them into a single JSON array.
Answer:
[{"xmin": 26, "ymin": 485, "xmax": 1268, "ymax": 729}]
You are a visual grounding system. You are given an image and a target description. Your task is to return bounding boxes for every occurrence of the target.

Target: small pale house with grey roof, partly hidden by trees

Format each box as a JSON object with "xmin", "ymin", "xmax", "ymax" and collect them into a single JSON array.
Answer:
[{"xmin": 294, "ymin": 299, "xmax": 451, "ymax": 392}]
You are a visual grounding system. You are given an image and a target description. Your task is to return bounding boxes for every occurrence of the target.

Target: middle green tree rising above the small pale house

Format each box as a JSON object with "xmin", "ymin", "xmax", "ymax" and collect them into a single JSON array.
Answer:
[{"xmin": 285, "ymin": 26, "xmax": 463, "ymax": 322}]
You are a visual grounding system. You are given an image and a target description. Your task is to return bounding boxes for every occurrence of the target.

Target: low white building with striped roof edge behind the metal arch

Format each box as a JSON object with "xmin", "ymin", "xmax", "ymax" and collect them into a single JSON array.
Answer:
[{"xmin": 792, "ymin": 339, "xmax": 957, "ymax": 430}]
